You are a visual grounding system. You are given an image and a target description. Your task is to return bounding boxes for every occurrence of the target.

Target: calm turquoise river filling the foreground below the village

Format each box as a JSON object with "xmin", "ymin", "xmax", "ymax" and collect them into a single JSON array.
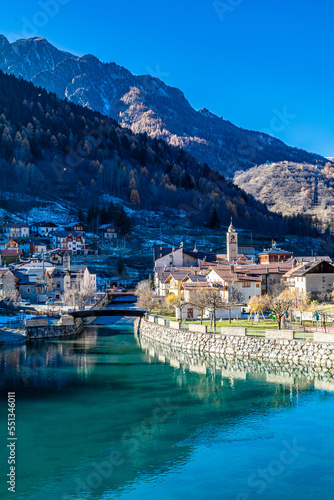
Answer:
[{"xmin": 0, "ymin": 322, "xmax": 334, "ymax": 500}]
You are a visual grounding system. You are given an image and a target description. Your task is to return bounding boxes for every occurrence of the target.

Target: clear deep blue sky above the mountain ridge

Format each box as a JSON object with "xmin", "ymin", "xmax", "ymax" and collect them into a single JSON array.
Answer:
[{"xmin": 0, "ymin": 0, "xmax": 334, "ymax": 156}]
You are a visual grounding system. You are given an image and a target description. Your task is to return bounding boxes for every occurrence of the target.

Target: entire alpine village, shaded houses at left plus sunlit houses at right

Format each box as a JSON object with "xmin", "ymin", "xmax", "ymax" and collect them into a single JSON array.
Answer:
[{"xmin": 0, "ymin": 216, "xmax": 334, "ymax": 327}]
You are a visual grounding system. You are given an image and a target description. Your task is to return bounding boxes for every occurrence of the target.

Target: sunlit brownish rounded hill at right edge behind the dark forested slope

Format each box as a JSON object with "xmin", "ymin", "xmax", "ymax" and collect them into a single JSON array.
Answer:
[{"xmin": 234, "ymin": 161, "xmax": 334, "ymax": 218}]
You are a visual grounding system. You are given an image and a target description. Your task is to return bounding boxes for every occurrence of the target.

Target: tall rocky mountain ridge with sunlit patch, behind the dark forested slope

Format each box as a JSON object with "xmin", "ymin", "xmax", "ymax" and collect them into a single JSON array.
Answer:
[{"xmin": 0, "ymin": 36, "xmax": 326, "ymax": 178}]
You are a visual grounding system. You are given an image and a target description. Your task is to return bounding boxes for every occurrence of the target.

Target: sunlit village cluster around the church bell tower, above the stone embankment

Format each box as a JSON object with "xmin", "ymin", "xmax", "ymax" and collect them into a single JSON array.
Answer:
[{"xmin": 149, "ymin": 221, "xmax": 334, "ymax": 328}]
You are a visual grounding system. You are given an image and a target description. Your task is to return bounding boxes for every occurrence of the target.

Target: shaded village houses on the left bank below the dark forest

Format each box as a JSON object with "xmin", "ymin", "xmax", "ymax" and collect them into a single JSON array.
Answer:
[{"xmin": 0, "ymin": 222, "xmax": 118, "ymax": 308}]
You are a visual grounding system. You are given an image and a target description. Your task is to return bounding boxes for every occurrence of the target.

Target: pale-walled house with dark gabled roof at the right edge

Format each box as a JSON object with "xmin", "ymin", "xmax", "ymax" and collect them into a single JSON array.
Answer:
[{"xmin": 283, "ymin": 260, "xmax": 334, "ymax": 298}]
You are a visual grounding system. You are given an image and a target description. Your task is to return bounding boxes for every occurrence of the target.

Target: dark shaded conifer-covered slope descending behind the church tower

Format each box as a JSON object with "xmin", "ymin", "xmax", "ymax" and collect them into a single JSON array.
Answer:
[{"xmin": 0, "ymin": 73, "xmax": 326, "ymax": 238}]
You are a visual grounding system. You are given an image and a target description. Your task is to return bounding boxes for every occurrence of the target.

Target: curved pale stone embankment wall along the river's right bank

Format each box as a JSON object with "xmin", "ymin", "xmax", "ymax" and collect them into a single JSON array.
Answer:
[{"xmin": 140, "ymin": 319, "xmax": 334, "ymax": 368}]
